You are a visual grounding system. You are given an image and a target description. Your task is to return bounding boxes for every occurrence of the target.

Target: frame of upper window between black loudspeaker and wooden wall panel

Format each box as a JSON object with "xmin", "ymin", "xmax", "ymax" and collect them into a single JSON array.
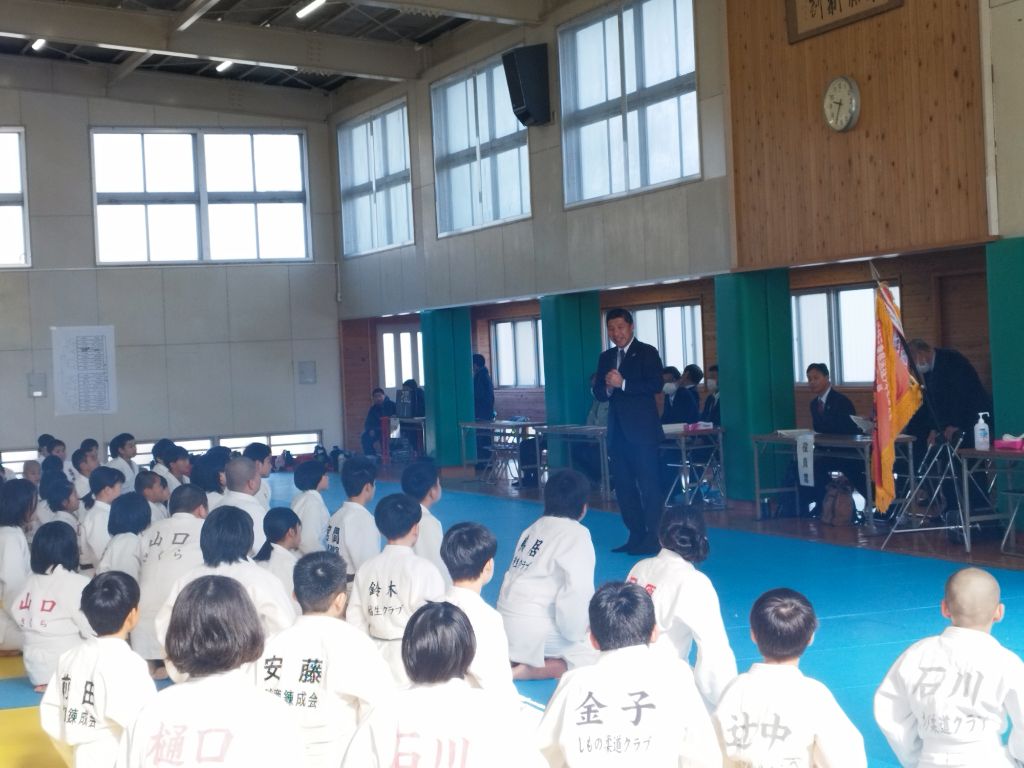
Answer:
[{"xmin": 556, "ymin": 0, "xmax": 703, "ymax": 210}]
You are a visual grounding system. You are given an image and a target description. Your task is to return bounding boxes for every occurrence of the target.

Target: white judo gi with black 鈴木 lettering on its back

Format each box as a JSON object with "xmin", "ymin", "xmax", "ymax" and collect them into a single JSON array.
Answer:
[{"xmin": 345, "ymin": 544, "xmax": 444, "ymax": 684}]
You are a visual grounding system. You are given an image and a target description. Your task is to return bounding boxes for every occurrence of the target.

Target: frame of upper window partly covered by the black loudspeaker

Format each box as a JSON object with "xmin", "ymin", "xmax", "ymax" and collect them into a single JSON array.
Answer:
[{"xmin": 430, "ymin": 53, "xmax": 534, "ymax": 240}]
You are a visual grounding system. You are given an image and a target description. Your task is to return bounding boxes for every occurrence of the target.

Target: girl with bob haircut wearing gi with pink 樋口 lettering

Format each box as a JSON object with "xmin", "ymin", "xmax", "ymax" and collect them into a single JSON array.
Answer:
[{"xmin": 118, "ymin": 577, "xmax": 303, "ymax": 768}]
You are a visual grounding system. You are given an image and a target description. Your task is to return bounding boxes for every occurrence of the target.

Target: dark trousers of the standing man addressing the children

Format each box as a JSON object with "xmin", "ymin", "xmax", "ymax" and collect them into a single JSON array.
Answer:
[{"xmin": 608, "ymin": 439, "xmax": 664, "ymax": 545}]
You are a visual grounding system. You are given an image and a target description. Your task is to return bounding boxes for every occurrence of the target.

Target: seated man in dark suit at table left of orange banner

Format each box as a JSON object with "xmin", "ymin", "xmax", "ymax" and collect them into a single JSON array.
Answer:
[{"xmin": 800, "ymin": 362, "xmax": 867, "ymax": 516}]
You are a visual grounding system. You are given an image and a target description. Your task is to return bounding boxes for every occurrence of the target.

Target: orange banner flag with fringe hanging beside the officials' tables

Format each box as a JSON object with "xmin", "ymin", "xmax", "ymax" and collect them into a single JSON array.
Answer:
[{"xmin": 868, "ymin": 283, "xmax": 923, "ymax": 514}]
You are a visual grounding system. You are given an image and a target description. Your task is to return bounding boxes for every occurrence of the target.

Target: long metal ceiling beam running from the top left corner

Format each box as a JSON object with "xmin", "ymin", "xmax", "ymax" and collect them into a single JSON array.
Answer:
[{"xmin": 0, "ymin": 0, "xmax": 423, "ymax": 80}]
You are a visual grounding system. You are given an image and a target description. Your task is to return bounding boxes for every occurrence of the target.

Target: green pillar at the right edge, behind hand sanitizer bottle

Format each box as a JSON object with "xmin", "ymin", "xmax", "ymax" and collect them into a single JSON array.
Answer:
[{"xmin": 986, "ymin": 238, "xmax": 1024, "ymax": 439}]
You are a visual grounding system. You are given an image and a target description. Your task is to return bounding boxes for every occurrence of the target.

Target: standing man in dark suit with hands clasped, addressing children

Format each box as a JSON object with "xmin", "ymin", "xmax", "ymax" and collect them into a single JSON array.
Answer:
[{"xmin": 594, "ymin": 308, "xmax": 665, "ymax": 555}]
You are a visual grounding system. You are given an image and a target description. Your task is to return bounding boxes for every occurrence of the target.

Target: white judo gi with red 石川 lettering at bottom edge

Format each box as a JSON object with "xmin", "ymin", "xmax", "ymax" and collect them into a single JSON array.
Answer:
[{"xmin": 342, "ymin": 678, "xmax": 544, "ymax": 768}]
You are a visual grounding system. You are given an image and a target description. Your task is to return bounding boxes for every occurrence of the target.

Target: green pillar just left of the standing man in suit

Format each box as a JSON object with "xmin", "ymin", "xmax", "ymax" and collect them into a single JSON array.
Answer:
[{"xmin": 541, "ymin": 291, "xmax": 601, "ymax": 466}]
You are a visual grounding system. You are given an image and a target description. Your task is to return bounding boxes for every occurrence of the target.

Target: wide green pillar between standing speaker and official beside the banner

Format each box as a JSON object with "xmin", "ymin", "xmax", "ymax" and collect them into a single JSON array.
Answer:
[{"xmin": 715, "ymin": 269, "xmax": 795, "ymax": 501}]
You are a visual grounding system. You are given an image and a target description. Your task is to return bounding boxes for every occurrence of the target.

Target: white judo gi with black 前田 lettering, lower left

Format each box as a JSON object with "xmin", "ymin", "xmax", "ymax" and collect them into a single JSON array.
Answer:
[{"xmin": 39, "ymin": 637, "xmax": 157, "ymax": 768}]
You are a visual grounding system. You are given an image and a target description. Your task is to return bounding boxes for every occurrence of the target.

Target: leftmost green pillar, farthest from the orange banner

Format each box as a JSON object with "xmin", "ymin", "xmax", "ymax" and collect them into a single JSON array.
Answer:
[{"xmin": 420, "ymin": 307, "xmax": 474, "ymax": 467}]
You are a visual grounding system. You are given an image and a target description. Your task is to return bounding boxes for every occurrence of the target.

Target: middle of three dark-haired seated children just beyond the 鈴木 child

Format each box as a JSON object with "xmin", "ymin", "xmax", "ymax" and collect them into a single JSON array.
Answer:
[{"xmin": 327, "ymin": 456, "xmax": 381, "ymax": 581}]
